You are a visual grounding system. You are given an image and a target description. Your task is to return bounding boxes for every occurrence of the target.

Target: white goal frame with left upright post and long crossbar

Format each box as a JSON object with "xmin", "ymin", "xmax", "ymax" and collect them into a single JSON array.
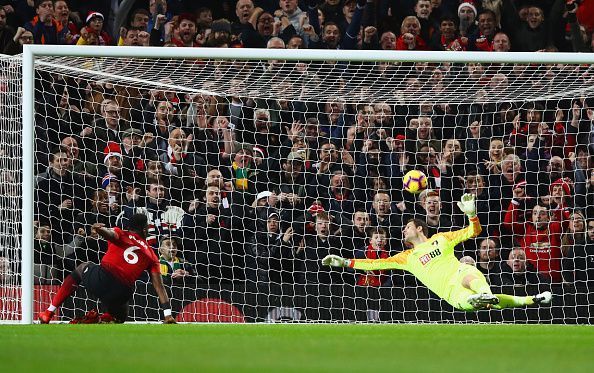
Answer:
[{"xmin": 9, "ymin": 45, "xmax": 594, "ymax": 324}]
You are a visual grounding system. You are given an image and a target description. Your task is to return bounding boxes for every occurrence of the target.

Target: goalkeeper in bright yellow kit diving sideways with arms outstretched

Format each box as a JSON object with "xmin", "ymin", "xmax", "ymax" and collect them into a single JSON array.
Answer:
[{"xmin": 322, "ymin": 194, "xmax": 552, "ymax": 311}]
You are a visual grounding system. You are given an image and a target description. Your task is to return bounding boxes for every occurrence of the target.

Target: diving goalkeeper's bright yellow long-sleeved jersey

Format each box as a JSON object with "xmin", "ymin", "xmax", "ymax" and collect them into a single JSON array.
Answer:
[{"xmin": 350, "ymin": 217, "xmax": 481, "ymax": 304}]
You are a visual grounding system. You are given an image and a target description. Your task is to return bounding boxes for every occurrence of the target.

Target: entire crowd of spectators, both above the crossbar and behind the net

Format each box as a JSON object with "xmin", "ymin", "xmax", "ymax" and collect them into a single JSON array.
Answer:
[{"xmin": 0, "ymin": 0, "xmax": 594, "ymax": 296}]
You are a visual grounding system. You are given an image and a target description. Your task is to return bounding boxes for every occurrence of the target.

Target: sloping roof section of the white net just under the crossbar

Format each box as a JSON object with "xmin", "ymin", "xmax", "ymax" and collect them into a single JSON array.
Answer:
[{"xmin": 38, "ymin": 57, "xmax": 594, "ymax": 104}]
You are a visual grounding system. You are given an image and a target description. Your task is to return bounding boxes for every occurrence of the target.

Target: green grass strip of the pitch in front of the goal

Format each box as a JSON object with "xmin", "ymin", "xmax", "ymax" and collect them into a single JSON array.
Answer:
[{"xmin": 0, "ymin": 324, "xmax": 594, "ymax": 373}]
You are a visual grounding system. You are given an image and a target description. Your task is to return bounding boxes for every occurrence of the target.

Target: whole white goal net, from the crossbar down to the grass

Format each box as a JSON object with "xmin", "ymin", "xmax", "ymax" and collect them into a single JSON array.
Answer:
[{"xmin": 0, "ymin": 48, "xmax": 594, "ymax": 323}]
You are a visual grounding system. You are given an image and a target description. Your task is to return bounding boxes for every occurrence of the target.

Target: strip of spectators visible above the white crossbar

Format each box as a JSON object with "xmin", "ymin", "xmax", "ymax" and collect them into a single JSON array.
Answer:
[{"xmin": 0, "ymin": 0, "xmax": 594, "ymax": 54}]
